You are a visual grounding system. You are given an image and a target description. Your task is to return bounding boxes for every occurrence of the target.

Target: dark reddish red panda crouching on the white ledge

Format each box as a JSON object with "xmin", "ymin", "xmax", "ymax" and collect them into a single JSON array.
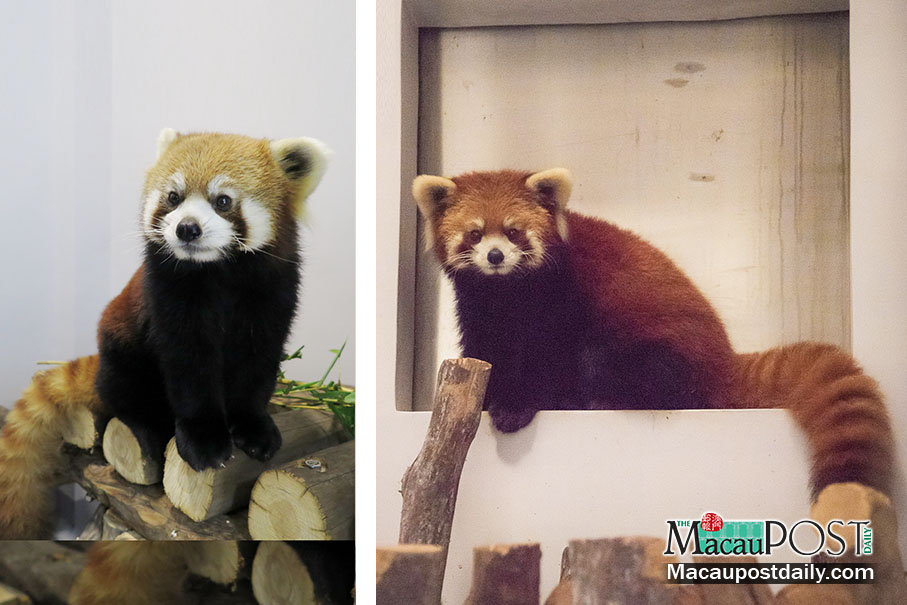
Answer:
[{"xmin": 413, "ymin": 168, "xmax": 893, "ymax": 496}]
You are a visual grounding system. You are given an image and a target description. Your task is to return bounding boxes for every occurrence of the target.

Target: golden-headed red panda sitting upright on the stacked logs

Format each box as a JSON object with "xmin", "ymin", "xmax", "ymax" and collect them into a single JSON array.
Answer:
[{"xmin": 0, "ymin": 129, "xmax": 327, "ymax": 538}]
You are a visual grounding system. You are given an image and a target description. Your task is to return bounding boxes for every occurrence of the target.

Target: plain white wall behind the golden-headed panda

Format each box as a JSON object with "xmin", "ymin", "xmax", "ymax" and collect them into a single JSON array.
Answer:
[{"xmin": 0, "ymin": 0, "xmax": 355, "ymax": 406}]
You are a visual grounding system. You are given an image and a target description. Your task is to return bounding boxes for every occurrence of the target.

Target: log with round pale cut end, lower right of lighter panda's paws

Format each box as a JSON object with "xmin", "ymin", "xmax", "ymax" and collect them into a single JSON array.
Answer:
[{"xmin": 249, "ymin": 441, "xmax": 356, "ymax": 540}]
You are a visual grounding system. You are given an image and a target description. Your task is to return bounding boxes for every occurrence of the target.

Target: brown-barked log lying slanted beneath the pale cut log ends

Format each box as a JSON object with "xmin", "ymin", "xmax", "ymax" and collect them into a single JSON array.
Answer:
[{"xmin": 79, "ymin": 464, "xmax": 249, "ymax": 540}]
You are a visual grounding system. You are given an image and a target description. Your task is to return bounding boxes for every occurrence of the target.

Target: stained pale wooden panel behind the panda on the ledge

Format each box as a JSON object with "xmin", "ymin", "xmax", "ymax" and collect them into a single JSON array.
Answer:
[{"xmin": 413, "ymin": 13, "xmax": 850, "ymax": 409}]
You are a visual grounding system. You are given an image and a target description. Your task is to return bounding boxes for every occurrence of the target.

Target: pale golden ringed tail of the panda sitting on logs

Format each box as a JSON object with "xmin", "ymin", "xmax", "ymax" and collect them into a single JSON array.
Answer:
[{"xmin": 0, "ymin": 355, "xmax": 101, "ymax": 540}]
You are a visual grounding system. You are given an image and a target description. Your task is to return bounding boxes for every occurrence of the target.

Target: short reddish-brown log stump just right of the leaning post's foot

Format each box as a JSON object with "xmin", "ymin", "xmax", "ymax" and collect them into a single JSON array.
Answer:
[{"xmin": 466, "ymin": 543, "xmax": 542, "ymax": 605}]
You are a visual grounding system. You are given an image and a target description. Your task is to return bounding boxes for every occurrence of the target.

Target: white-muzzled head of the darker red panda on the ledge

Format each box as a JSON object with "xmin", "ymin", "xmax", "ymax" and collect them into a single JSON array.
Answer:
[{"xmin": 413, "ymin": 169, "xmax": 570, "ymax": 276}]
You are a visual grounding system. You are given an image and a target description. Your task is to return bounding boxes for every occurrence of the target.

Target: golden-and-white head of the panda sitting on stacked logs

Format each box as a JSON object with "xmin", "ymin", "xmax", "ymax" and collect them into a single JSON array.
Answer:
[{"xmin": 142, "ymin": 129, "xmax": 327, "ymax": 263}]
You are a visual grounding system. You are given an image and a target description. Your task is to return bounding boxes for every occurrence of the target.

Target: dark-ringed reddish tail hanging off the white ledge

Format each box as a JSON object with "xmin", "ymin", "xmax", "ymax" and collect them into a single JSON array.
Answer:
[{"xmin": 737, "ymin": 342, "xmax": 894, "ymax": 499}]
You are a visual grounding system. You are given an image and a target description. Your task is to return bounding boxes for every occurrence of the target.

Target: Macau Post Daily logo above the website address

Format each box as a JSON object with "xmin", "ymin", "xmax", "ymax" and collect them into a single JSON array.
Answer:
[{"xmin": 664, "ymin": 512, "xmax": 872, "ymax": 557}]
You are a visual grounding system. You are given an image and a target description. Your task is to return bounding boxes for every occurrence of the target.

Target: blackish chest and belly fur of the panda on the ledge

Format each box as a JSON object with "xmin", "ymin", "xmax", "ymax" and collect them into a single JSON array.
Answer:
[{"xmin": 451, "ymin": 246, "xmax": 706, "ymax": 422}]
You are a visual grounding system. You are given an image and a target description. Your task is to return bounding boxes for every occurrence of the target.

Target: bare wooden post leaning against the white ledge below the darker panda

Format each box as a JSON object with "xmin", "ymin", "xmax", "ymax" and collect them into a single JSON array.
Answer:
[{"xmin": 400, "ymin": 358, "xmax": 491, "ymax": 602}]
